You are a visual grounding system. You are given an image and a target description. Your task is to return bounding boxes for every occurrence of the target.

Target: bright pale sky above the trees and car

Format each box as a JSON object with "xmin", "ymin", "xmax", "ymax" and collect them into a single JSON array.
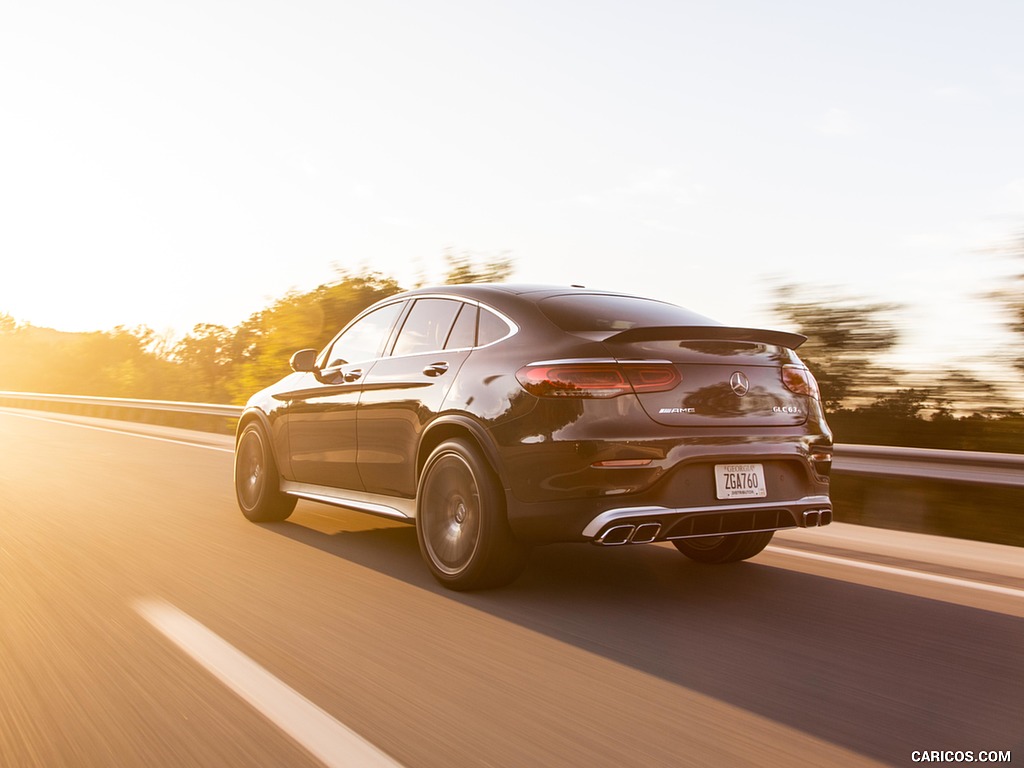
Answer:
[{"xmin": 0, "ymin": 0, "xmax": 1024, "ymax": 376}]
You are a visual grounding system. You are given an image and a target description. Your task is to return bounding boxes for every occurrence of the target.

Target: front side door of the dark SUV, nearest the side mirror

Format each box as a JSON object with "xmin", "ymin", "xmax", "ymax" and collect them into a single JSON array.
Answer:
[{"xmin": 286, "ymin": 301, "xmax": 406, "ymax": 490}]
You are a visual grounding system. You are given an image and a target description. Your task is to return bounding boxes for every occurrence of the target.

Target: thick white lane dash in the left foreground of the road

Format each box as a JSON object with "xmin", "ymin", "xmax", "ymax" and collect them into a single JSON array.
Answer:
[{"xmin": 135, "ymin": 600, "xmax": 400, "ymax": 768}]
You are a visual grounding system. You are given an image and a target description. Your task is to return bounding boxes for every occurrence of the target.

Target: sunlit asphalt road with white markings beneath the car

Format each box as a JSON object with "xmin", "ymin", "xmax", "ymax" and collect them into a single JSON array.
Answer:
[{"xmin": 0, "ymin": 411, "xmax": 1024, "ymax": 768}]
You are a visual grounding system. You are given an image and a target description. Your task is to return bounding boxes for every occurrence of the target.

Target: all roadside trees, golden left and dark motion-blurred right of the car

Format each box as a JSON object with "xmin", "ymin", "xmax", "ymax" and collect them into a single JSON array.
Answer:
[{"xmin": 0, "ymin": 244, "xmax": 1024, "ymax": 453}]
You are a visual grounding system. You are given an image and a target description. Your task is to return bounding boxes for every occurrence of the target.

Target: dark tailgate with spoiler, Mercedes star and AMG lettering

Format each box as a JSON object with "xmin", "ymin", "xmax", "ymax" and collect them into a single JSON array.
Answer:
[{"xmin": 604, "ymin": 326, "xmax": 809, "ymax": 427}]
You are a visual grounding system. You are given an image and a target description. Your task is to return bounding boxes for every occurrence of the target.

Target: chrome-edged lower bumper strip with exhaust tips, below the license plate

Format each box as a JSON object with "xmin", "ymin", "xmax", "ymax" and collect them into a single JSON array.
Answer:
[{"xmin": 583, "ymin": 496, "xmax": 833, "ymax": 546}]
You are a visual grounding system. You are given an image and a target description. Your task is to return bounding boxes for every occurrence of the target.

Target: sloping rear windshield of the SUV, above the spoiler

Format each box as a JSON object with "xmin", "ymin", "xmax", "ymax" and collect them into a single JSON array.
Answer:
[{"xmin": 539, "ymin": 294, "xmax": 721, "ymax": 333}]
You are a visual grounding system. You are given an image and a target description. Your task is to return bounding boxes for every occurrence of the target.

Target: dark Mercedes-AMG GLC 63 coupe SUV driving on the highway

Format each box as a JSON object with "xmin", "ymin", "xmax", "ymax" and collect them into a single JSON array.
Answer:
[{"xmin": 234, "ymin": 285, "xmax": 833, "ymax": 590}]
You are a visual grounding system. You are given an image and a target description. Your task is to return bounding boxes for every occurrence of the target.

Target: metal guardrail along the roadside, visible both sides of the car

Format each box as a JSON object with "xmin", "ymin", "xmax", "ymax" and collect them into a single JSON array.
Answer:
[{"xmin": 0, "ymin": 391, "xmax": 1024, "ymax": 487}]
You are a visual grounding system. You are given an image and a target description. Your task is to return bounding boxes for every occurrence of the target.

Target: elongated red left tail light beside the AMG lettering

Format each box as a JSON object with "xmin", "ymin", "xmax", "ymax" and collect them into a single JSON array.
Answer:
[{"xmin": 515, "ymin": 360, "xmax": 681, "ymax": 397}]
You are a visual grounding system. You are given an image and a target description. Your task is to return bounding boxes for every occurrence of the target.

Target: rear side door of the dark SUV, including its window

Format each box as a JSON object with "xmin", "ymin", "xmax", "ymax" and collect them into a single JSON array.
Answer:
[{"xmin": 357, "ymin": 297, "xmax": 478, "ymax": 499}]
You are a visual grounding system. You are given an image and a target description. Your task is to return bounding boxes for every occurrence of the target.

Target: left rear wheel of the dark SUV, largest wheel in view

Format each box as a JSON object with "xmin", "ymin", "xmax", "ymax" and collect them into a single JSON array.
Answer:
[{"xmin": 416, "ymin": 439, "xmax": 526, "ymax": 591}]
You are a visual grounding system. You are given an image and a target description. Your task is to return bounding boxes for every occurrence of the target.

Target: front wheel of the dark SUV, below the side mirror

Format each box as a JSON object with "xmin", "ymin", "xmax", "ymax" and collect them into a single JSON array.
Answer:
[{"xmin": 234, "ymin": 422, "xmax": 297, "ymax": 522}]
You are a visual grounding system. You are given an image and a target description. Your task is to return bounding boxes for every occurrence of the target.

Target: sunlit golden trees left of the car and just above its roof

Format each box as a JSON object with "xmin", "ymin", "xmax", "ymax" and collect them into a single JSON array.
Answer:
[{"xmin": 0, "ymin": 251, "xmax": 513, "ymax": 404}]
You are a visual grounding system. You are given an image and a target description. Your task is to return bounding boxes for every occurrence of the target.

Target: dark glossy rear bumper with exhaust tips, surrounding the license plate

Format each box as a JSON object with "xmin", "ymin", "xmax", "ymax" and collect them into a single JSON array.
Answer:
[{"xmin": 489, "ymin": 397, "xmax": 833, "ymax": 545}]
